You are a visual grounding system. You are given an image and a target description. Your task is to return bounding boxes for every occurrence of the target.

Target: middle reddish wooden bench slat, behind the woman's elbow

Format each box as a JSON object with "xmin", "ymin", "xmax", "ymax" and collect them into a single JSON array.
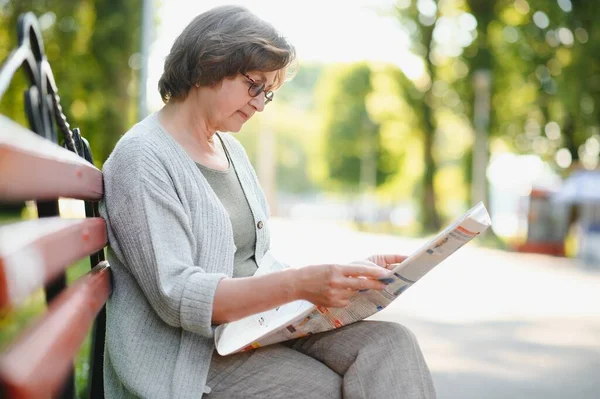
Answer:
[{"xmin": 0, "ymin": 217, "xmax": 107, "ymax": 309}]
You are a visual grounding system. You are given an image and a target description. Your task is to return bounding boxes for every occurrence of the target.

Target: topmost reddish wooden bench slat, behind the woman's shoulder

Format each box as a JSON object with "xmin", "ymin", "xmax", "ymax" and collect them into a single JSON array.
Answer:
[{"xmin": 0, "ymin": 115, "xmax": 103, "ymax": 201}]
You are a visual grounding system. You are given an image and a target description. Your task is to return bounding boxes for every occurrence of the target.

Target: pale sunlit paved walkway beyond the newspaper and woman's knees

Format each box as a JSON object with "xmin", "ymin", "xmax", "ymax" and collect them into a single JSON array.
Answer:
[{"xmin": 271, "ymin": 219, "xmax": 600, "ymax": 399}]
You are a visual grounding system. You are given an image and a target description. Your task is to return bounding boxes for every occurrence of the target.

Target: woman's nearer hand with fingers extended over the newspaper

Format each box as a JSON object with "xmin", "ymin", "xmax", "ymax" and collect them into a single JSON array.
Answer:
[{"xmin": 294, "ymin": 264, "xmax": 390, "ymax": 308}]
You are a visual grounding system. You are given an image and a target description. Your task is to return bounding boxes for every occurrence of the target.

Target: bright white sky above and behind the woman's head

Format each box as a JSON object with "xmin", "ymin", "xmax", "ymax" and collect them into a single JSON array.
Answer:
[{"xmin": 148, "ymin": 0, "xmax": 423, "ymax": 110}]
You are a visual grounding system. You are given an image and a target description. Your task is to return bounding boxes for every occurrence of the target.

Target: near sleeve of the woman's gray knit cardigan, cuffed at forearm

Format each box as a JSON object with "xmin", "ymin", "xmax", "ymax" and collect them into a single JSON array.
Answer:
[{"xmin": 100, "ymin": 136, "xmax": 226, "ymax": 338}]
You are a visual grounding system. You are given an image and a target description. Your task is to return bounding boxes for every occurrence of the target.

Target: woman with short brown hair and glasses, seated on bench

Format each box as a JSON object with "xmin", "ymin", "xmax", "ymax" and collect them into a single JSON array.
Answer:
[{"xmin": 101, "ymin": 6, "xmax": 435, "ymax": 399}]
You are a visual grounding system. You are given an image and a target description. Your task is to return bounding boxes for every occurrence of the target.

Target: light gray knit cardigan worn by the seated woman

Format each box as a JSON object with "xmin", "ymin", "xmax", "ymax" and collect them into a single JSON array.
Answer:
[{"xmin": 100, "ymin": 114, "xmax": 269, "ymax": 399}]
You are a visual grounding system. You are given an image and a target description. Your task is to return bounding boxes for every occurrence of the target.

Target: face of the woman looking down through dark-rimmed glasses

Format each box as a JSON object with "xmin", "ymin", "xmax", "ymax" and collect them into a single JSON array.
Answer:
[{"xmin": 214, "ymin": 71, "xmax": 277, "ymax": 132}]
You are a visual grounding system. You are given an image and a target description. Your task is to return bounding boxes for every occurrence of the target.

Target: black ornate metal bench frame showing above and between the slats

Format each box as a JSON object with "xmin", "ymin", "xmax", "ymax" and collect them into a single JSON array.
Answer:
[{"xmin": 0, "ymin": 13, "xmax": 106, "ymax": 398}]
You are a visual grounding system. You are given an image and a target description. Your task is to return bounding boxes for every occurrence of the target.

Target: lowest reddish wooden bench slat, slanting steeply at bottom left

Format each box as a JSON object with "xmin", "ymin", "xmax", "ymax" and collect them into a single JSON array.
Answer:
[{"xmin": 0, "ymin": 262, "xmax": 111, "ymax": 398}]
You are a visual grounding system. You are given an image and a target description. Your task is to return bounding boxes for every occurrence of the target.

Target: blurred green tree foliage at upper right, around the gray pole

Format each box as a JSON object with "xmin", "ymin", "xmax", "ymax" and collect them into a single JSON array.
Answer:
[{"xmin": 380, "ymin": 0, "xmax": 600, "ymax": 230}]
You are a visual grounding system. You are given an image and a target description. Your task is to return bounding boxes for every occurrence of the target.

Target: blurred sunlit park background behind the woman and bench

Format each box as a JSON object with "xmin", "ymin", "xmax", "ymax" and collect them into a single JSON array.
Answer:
[{"xmin": 0, "ymin": 0, "xmax": 600, "ymax": 398}]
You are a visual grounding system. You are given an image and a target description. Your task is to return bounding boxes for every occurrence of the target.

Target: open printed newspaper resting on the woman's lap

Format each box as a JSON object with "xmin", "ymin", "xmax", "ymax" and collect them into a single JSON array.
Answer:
[{"xmin": 215, "ymin": 202, "xmax": 491, "ymax": 356}]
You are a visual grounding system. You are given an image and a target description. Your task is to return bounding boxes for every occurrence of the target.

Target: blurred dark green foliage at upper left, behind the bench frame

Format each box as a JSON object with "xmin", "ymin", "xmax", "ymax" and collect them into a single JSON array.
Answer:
[{"xmin": 0, "ymin": 0, "xmax": 141, "ymax": 166}]
